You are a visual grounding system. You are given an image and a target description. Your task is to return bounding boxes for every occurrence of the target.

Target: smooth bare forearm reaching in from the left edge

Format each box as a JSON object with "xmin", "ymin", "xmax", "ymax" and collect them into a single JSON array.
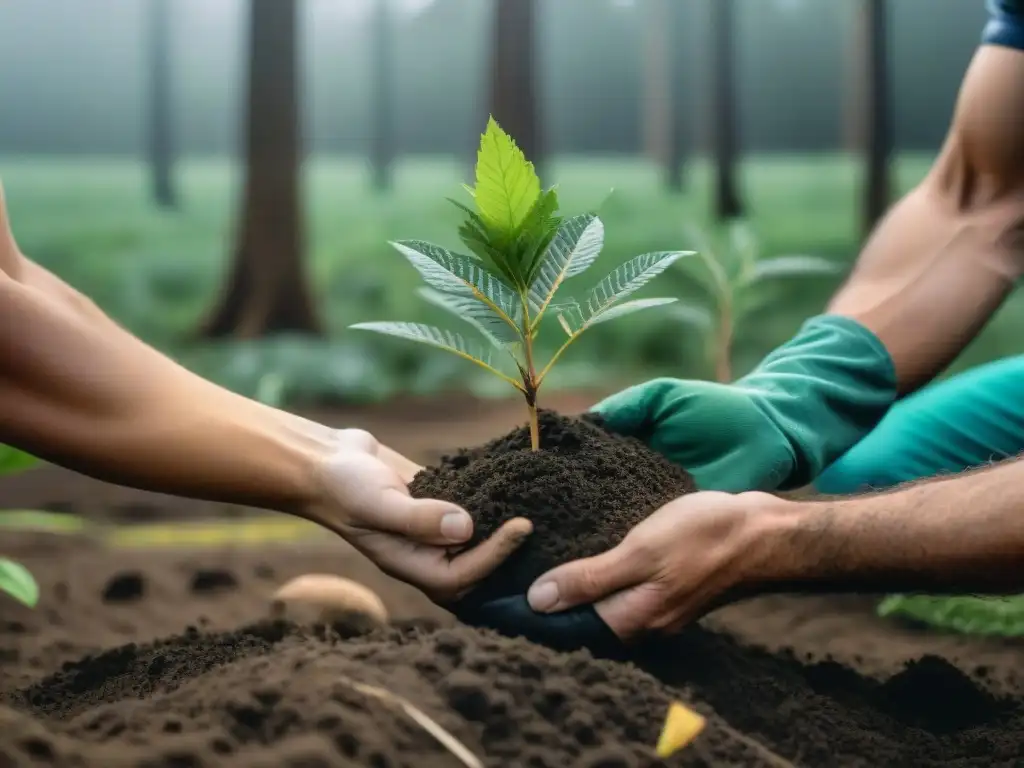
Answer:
[{"xmin": 0, "ymin": 274, "xmax": 330, "ymax": 511}]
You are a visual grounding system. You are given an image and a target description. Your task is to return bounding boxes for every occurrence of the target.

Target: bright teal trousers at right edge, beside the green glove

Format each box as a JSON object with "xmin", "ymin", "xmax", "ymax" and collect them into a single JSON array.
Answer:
[{"xmin": 814, "ymin": 355, "xmax": 1024, "ymax": 494}]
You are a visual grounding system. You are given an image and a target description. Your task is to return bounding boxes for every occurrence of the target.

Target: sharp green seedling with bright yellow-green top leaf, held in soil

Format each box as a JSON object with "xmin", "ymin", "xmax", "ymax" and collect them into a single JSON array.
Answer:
[{"xmin": 351, "ymin": 118, "xmax": 693, "ymax": 451}]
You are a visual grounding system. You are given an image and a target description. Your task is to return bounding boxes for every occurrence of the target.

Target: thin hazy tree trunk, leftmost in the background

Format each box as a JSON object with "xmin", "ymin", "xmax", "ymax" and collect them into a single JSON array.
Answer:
[{"xmin": 148, "ymin": 0, "xmax": 178, "ymax": 208}]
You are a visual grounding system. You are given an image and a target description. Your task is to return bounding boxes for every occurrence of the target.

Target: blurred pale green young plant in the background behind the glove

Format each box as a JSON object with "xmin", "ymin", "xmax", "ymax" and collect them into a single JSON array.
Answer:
[{"xmin": 669, "ymin": 221, "xmax": 839, "ymax": 383}]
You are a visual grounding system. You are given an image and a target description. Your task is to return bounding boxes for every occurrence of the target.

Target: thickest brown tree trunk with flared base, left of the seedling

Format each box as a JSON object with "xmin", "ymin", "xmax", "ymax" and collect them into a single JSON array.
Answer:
[{"xmin": 205, "ymin": 0, "xmax": 319, "ymax": 338}]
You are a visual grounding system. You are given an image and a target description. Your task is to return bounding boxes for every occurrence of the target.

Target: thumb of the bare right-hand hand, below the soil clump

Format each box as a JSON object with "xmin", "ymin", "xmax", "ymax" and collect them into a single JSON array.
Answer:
[{"xmin": 526, "ymin": 544, "xmax": 647, "ymax": 613}]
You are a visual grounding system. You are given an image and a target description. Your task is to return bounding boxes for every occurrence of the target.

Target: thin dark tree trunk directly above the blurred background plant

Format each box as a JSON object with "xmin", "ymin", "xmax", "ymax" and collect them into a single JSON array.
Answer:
[{"xmin": 711, "ymin": 0, "xmax": 743, "ymax": 220}]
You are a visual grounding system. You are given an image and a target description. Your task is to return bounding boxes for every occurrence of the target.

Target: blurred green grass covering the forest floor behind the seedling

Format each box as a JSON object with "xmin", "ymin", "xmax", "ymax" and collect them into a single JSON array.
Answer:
[{"xmin": 12, "ymin": 150, "xmax": 1024, "ymax": 401}]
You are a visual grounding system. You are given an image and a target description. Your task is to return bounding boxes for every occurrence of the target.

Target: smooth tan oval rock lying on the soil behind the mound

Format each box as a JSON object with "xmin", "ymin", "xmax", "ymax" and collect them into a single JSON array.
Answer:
[{"xmin": 270, "ymin": 573, "xmax": 388, "ymax": 632}]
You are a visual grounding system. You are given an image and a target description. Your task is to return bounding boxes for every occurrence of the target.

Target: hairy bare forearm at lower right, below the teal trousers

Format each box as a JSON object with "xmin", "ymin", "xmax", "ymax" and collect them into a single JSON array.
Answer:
[{"xmin": 763, "ymin": 460, "xmax": 1024, "ymax": 594}]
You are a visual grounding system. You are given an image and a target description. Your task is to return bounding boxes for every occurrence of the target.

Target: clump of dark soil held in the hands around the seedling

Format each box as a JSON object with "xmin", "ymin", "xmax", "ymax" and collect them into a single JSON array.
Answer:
[{"xmin": 410, "ymin": 411, "xmax": 696, "ymax": 601}]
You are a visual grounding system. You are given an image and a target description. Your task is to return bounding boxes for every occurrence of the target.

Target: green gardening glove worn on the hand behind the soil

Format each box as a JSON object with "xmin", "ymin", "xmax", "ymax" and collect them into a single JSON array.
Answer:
[{"xmin": 594, "ymin": 314, "xmax": 896, "ymax": 493}]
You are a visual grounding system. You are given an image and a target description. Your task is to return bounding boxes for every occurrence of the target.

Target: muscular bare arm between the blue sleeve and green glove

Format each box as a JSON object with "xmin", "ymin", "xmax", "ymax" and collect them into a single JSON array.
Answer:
[{"xmin": 829, "ymin": 46, "xmax": 1024, "ymax": 393}]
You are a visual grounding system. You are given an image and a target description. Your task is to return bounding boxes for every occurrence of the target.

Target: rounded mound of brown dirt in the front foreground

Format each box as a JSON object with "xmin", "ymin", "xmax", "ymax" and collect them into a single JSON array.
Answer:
[{"xmin": 6, "ymin": 623, "xmax": 770, "ymax": 768}]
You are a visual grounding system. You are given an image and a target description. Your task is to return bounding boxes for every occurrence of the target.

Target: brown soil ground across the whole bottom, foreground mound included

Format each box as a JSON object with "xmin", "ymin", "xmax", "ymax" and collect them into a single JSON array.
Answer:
[{"xmin": 0, "ymin": 538, "xmax": 1024, "ymax": 768}]
